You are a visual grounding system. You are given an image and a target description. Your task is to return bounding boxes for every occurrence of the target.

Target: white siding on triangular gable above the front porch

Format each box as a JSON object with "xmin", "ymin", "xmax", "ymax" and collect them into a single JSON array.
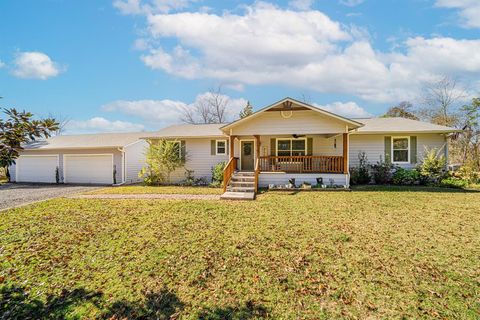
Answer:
[{"xmin": 232, "ymin": 110, "xmax": 346, "ymax": 135}]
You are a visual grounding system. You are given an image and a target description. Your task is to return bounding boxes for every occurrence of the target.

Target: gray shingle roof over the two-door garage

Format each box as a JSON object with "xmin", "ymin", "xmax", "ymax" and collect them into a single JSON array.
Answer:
[{"xmin": 24, "ymin": 132, "xmax": 148, "ymax": 150}]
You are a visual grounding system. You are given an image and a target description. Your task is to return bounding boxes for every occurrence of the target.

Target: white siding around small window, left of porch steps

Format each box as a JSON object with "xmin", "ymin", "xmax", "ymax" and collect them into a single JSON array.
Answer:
[{"xmin": 171, "ymin": 138, "xmax": 229, "ymax": 183}]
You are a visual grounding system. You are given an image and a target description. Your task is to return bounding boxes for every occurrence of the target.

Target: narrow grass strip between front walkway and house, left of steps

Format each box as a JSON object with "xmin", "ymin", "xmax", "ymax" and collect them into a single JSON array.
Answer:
[{"xmin": 86, "ymin": 185, "xmax": 223, "ymax": 195}]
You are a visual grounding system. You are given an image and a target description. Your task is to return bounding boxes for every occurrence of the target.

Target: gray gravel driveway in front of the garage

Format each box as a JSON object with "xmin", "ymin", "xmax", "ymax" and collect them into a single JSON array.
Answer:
[{"xmin": 0, "ymin": 183, "xmax": 101, "ymax": 210}]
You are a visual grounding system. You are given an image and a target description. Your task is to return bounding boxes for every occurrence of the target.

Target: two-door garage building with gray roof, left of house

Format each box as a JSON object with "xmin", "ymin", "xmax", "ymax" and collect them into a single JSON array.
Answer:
[{"xmin": 10, "ymin": 132, "xmax": 148, "ymax": 185}]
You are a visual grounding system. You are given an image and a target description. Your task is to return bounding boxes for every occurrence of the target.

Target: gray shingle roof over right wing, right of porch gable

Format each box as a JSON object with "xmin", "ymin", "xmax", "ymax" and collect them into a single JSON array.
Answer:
[{"xmin": 356, "ymin": 118, "xmax": 461, "ymax": 133}]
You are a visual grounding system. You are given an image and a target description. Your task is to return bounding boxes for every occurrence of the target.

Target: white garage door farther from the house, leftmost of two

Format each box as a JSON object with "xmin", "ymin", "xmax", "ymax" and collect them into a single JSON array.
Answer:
[{"xmin": 16, "ymin": 155, "xmax": 58, "ymax": 183}]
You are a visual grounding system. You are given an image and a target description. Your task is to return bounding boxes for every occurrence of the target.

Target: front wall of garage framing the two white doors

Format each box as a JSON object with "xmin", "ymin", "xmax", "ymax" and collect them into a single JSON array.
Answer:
[{"xmin": 10, "ymin": 148, "xmax": 123, "ymax": 183}]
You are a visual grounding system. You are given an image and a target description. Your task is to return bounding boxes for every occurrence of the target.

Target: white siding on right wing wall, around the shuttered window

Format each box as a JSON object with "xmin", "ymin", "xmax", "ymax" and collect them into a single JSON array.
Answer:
[{"xmin": 350, "ymin": 133, "xmax": 446, "ymax": 168}]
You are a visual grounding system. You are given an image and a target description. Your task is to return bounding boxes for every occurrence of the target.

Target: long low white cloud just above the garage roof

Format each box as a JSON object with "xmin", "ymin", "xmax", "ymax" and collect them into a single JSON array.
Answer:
[{"xmin": 65, "ymin": 117, "xmax": 145, "ymax": 134}]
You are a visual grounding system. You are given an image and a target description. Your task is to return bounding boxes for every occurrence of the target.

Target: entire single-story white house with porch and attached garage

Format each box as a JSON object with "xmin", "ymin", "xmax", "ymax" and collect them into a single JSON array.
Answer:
[{"xmin": 11, "ymin": 98, "xmax": 458, "ymax": 196}]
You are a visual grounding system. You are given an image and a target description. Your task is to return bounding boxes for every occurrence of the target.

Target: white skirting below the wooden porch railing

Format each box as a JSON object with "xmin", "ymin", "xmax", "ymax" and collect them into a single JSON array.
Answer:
[{"xmin": 258, "ymin": 173, "xmax": 347, "ymax": 187}]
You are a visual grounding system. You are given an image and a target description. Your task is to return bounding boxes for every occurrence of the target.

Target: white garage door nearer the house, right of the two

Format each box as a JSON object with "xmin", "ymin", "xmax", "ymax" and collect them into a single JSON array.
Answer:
[{"xmin": 63, "ymin": 154, "xmax": 113, "ymax": 184}]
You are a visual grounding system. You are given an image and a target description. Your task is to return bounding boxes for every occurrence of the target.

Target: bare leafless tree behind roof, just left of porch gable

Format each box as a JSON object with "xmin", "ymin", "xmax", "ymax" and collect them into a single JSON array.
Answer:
[{"xmin": 180, "ymin": 86, "xmax": 230, "ymax": 124}]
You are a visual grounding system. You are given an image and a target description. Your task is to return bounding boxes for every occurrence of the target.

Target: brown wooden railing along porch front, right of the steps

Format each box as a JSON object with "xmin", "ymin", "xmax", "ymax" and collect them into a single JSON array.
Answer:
[{"xmin": 259, "ymin": 156, "xmax": 344, "ymax": 173}]
